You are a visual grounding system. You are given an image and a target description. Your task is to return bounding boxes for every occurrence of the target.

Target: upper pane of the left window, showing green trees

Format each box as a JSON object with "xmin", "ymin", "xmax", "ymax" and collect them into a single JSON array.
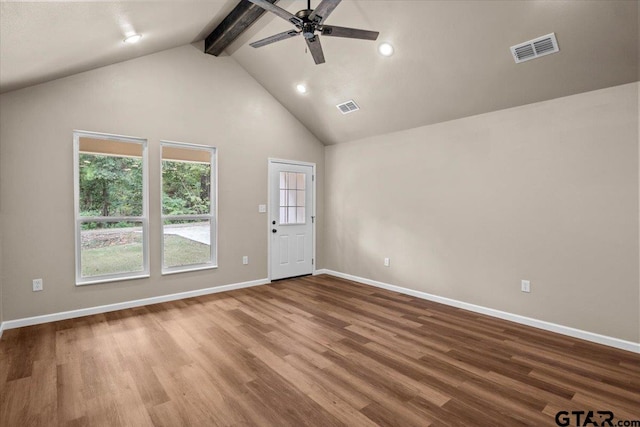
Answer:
[{"xmin": 78, "ymin": 153, "xmax": 143, "ymax": 217}]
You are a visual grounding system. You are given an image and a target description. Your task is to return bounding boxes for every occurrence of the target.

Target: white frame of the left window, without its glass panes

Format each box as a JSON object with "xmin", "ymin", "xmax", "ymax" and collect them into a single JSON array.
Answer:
[{"xmin": 73, "ymin": 130, "xmax": 150, "ymax": 286}]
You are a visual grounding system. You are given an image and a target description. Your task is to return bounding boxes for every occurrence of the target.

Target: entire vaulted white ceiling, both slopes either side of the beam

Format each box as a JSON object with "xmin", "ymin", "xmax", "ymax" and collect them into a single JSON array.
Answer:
[{"xmin": 0, "ymin": 0, "xmax": 639, "ymax": 144}]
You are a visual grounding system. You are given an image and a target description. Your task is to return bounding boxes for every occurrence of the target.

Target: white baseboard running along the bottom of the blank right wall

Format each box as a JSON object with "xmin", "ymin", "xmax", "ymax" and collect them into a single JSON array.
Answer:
[{"xmin": 314, "ymin": 269, "xmax": 640, "ymax": 353}]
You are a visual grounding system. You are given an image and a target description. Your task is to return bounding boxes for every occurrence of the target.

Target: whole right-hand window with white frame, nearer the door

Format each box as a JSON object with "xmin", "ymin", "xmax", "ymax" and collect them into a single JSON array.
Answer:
[{"xmin": 161, "ymin": 141, "xmax": 216, "ymax": 274}]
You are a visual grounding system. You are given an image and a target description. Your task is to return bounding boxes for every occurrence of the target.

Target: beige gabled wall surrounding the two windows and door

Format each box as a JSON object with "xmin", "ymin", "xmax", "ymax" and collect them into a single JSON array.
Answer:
[{"xmin": 0, "ymin": 46, "xmax": 324, "ymax": 321}]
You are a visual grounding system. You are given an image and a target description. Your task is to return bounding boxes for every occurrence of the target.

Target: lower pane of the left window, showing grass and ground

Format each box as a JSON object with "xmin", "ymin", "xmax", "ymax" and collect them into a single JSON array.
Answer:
[{"xmin": 80, "ymin": 222, "xmax": 144, "ymax": 278}]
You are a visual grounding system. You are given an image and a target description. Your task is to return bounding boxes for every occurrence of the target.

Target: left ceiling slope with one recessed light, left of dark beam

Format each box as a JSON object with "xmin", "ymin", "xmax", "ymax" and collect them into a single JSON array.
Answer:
[{"xmin": 0, "ymin": 0, "xmax": 237, "ymax": 92}]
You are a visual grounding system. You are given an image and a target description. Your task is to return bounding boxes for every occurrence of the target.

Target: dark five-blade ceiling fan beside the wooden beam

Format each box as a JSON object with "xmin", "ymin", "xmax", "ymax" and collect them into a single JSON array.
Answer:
[{"xmin": 244, "ymin": 0, "xmax": 379, "ymax": 64}]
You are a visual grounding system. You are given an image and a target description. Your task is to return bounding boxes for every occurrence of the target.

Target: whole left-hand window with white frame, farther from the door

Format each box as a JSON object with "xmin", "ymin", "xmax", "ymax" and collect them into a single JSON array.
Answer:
[{"xmin": 73, "ymin": 131, "xmax": 149, "ymax": 285}]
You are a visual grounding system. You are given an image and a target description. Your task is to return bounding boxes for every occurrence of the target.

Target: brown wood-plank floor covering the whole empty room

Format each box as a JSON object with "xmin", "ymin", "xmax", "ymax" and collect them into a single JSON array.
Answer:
[{"xmin": 0, "ymin": 276, "xmax": 640, "ymax": 426}]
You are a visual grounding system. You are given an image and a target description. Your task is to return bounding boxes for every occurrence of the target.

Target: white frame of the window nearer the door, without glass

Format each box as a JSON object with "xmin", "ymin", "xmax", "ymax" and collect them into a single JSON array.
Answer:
[{"xmin": 160, "ymin": 140, "xmax": 218, "ymax": 276}]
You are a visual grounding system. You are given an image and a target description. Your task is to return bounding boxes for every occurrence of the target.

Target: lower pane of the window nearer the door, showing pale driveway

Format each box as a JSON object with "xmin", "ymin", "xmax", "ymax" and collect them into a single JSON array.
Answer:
[{"xmin": 163, "ymin": 220, "xmax": 211, "ymax": 268}]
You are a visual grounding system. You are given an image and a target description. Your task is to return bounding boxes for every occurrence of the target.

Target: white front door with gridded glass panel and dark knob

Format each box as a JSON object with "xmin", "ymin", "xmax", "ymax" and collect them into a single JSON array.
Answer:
[{"xmin": 269, "ymin": 160, "xmax": 315, "ymax": 280}]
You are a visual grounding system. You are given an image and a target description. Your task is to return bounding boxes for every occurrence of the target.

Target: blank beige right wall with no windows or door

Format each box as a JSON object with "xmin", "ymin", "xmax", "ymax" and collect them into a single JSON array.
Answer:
[{"xmin": 324, "ymin": 83, "xmax": 640, "ymax": 342}]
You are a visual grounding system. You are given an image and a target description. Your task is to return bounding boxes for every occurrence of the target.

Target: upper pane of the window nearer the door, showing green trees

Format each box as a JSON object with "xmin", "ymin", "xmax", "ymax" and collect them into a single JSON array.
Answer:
[{"xmin": 162, "ymin": 159, "xmax": 211, "ymax": 215}]
